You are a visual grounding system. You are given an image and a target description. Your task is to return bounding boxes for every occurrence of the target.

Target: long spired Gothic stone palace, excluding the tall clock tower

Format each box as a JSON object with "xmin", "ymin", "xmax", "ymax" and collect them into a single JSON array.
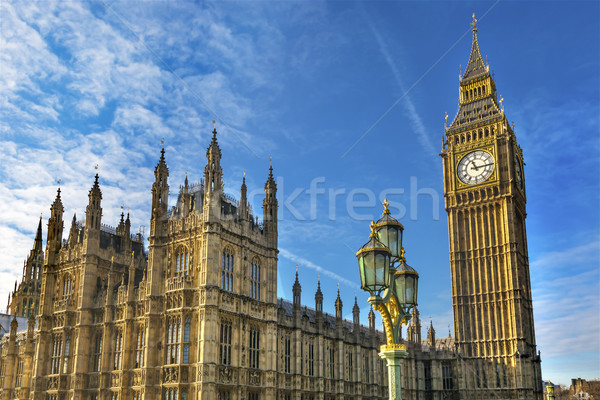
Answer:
[{"xmin": 0, "ymin": 130, "xmax": 460, "ymax": 400}]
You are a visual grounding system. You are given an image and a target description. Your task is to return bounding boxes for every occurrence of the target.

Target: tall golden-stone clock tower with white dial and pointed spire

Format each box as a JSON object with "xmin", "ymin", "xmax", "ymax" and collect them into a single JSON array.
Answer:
[{"xmin": 441, "ymin": 16, "xmax": 542, "ymax": 399}]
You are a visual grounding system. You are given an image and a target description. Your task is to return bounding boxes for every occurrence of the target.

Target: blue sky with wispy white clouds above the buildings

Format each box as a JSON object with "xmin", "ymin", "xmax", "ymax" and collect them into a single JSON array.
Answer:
[{"xmin": 0, "ymin": 1, "xmax": 600, "ymax": 383}]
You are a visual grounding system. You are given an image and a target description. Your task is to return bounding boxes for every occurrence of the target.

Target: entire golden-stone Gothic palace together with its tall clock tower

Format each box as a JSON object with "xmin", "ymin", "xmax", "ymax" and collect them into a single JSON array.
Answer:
[{"xmin": 0, "ymin": 16, "xmax": 542, "ymax": 400}]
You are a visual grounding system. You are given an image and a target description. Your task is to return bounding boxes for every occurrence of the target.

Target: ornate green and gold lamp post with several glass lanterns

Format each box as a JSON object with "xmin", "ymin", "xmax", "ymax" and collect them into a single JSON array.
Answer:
[{"xmin": 356, "ymin": 199, "xmax": 419, "ymax": 400}]
